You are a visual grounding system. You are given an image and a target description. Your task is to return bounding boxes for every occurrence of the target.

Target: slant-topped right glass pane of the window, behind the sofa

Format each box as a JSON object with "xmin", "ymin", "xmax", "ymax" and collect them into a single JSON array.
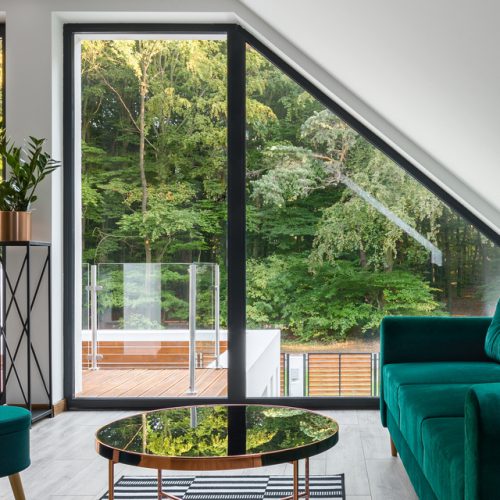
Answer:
[{"xmin": 247, "ymin": 47, "xmax": 500, "ymax": 397}]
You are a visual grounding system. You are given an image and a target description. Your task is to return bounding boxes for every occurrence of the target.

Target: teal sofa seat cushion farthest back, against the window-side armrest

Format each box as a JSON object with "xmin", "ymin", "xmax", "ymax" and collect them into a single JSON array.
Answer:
[{"xmin": 382, "ymin": 362, "xmax": 500, "ymax": 425}]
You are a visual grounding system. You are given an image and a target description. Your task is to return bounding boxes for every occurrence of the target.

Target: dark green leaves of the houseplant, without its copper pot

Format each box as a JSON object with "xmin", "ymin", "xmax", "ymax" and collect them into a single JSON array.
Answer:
[{"xmin": 0, "ymin": 129, "xmax": 61, "ymax": 212}]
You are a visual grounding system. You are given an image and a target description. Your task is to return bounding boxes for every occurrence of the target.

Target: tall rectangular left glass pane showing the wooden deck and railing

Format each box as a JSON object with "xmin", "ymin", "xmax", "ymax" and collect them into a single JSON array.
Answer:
[{"xmin": 77, "ymin": 37, "xmax": 227, "ymax": 397}]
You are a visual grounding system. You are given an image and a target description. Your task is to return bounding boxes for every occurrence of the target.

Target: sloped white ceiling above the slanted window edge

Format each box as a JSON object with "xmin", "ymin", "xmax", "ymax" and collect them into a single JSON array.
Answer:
[{"xmin": 240, "ymin": 0, "xmax": 500, "ymax": 231}]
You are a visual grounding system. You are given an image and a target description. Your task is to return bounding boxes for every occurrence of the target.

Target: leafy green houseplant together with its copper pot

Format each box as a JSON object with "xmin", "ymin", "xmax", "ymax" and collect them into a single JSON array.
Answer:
[{"xmin": 0, "ymin": 130, "xmax": 61, "ymax": 241}]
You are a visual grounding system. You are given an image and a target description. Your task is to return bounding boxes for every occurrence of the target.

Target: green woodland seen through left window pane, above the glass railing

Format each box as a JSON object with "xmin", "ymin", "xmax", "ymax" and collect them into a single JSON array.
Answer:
[{"xmin": 82, "ymin": 40, "xmax": 234, "ymax": 262}]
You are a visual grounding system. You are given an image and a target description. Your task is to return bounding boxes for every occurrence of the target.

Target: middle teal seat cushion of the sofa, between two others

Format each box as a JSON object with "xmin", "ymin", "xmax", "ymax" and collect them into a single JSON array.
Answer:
[{"xmin": 399, "ymin": 384, "xmax": 470, "ymax": 466}]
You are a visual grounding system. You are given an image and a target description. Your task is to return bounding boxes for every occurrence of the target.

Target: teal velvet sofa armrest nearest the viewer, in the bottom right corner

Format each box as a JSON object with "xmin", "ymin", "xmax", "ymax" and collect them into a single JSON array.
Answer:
[{"xmin": 465, "ymin": 383, "xmax": 500, "ymax": 500}]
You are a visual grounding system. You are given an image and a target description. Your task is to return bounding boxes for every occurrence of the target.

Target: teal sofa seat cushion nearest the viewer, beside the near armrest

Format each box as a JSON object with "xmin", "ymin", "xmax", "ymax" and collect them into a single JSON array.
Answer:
[{"xmin": 422, "ymin": 417, "xmax": 465, "ymax": 500}]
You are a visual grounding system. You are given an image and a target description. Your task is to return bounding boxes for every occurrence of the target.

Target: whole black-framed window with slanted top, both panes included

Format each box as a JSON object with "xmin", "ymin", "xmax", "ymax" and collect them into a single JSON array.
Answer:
[{"xmin": 64, "ymin": 25, "xmax": 500, "ymax": 407}]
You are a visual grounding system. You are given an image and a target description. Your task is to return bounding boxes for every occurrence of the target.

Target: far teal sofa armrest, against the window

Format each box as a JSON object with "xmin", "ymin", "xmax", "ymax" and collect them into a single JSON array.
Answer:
[{"xmin": 380, "ymin": 316, "xmax": 491, "ymax": 425}]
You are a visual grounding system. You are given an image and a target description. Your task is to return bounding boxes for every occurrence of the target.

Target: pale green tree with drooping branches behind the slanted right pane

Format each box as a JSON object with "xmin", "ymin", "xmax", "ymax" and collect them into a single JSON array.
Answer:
[{"xmin": 253, "ymin": 110, "xmax": 441, "ymax": 270}]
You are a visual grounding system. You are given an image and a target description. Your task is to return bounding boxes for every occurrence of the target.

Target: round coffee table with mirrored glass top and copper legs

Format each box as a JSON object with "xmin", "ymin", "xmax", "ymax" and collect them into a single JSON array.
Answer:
[{"xmin": 96, "ymin": 405, "xmax": 339, "ymax": 500}]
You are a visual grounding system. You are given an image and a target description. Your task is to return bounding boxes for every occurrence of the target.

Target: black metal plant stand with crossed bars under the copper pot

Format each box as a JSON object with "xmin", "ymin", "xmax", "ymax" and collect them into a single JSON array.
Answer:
[{"xmin": 0, "ymin": 241, "xmax": 53, "ymax": 422}]
